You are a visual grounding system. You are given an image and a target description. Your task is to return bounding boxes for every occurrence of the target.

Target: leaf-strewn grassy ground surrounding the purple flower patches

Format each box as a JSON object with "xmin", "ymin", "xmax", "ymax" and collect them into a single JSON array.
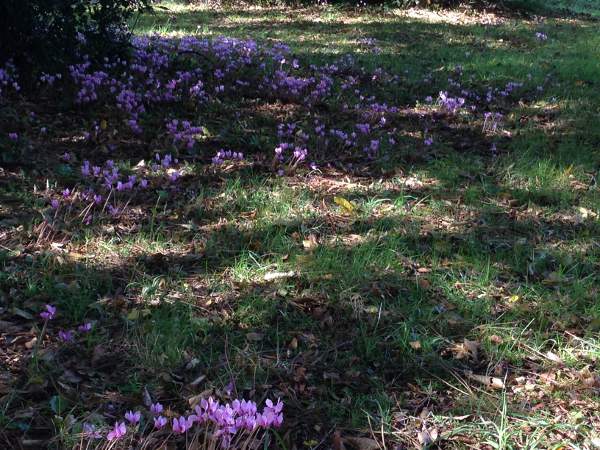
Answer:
[{"xmin": 0, "ymin": 3, "xmax": 600, "ymax": 449}]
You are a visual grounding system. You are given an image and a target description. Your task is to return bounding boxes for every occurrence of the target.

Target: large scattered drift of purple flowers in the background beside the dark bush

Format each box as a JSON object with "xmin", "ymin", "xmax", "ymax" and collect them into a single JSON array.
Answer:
[{"xmin": 7, "ymin": 29, "xmax": 544, "ymax": 223}]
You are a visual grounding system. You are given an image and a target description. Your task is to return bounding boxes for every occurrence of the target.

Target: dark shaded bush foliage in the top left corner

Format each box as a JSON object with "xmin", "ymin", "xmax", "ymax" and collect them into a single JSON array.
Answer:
[{"xmin": 0, "ymin": 0, "xmax": 150, "ymax": 81}]
